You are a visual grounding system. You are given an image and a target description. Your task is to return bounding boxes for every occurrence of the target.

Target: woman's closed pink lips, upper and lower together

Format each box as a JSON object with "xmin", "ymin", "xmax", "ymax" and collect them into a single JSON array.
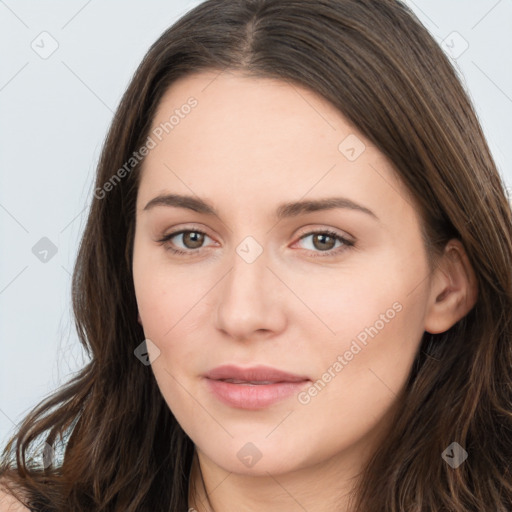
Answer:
[{"xmin": 205, "ymin": 365, "xmax": 310, "ymax": 410}]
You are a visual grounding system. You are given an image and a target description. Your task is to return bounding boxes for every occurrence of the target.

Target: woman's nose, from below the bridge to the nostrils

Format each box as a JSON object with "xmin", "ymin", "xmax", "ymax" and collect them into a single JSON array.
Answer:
[{"xmin": 216, "ymin": 246, "xmax": 287, "ymax": 341}]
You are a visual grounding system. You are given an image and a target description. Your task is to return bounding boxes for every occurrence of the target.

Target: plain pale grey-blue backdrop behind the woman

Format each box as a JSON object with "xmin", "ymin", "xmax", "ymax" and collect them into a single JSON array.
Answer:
[{"xmin": 0, "ymin": 0, "xmax": 512, "ymax": 447}]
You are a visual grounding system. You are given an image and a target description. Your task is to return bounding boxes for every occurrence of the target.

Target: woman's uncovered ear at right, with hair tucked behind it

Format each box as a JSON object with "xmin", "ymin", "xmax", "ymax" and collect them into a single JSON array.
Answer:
[{"xmin": 425, "ymin": 238, "xmax": 478, "ymax": 334}]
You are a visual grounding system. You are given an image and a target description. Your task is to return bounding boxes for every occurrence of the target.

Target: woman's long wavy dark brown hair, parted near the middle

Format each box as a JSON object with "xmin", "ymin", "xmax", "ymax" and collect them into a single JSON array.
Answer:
[{"xmin": 0, "ymin": 0, "xmax": 512, "ymax": 512}]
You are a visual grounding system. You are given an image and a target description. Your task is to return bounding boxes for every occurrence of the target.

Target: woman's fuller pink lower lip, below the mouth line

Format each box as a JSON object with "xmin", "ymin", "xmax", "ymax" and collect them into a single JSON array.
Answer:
[{"xmin": 206, "ymin": 378, "xmax": 310, "ymax": 409}]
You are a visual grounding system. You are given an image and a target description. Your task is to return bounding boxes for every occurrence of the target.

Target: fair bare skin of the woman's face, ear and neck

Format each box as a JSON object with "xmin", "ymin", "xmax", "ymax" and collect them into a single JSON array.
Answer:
[{"xmin": 133, "ymin": 71, "xmax": 477, "ymax": 512}]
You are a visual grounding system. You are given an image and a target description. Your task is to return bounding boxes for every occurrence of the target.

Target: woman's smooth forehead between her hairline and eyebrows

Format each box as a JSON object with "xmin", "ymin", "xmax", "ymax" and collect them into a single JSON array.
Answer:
[{"xmin": 139, "ymin": 71, "xmax": 414, "ymax": 218}]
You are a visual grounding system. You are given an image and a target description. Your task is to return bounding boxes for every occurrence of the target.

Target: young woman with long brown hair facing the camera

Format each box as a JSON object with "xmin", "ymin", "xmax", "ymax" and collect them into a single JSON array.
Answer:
[{"xmin": 2, "ymin": 0, "xmax": 512, "ymax": 512}]
